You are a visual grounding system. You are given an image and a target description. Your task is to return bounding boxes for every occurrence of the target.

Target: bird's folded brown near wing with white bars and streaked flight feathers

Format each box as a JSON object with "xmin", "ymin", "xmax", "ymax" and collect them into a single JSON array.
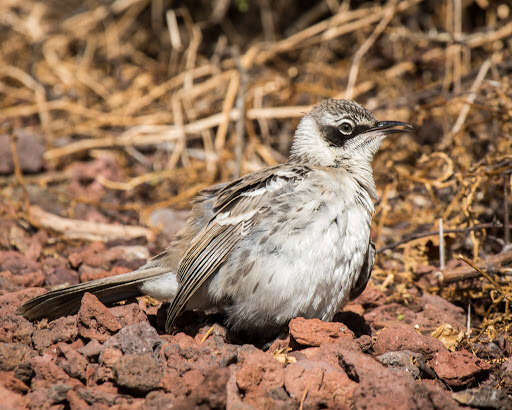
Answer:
[{"xmin": 166, "ymin": 164, "xmax": 310, "ymax": 331}]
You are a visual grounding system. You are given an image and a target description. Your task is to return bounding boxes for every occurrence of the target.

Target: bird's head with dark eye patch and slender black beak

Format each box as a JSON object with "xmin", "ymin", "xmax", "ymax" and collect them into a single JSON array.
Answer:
[{"xmin": 290, "ymin": 99, "xmax": 414, "ymax": 168}]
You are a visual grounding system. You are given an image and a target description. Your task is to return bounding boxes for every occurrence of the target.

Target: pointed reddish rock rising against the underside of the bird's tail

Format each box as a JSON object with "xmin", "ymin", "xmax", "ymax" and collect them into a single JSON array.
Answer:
[{"xmin": 78, "ymin": 293, "xmax": 121, "ymax": 342}]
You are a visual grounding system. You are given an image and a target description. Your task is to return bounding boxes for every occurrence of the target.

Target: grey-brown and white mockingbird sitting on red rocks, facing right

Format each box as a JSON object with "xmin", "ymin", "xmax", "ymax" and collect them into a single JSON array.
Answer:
[{"xmin": 18, "ymin": 99, "xmax": 415, "ymax": 339}]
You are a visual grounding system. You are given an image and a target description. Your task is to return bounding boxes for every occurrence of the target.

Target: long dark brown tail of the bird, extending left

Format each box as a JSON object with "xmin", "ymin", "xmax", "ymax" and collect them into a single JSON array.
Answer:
[{"xmin": 17, "ymin": 264, "xmax": 169, "ymax": 320}]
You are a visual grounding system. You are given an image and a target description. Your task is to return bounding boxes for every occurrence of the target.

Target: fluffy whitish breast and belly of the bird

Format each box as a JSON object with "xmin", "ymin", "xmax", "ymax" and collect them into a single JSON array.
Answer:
[{"xmin": 210, "ymin": 168, "xmax": 373, "ymax": 332}]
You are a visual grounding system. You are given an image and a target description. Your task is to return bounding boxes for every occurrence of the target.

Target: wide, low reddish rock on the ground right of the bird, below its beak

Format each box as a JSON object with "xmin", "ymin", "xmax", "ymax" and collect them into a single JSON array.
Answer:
[{"xmin": 373, "ymin": 325, "xmax": 446, "ymax": 357}]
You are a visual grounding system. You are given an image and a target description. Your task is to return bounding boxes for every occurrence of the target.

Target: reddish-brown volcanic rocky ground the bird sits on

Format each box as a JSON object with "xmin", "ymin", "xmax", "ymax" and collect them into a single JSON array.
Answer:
[{"xmin": 0, "ymin": 223, "xmax": 512, "ymax": 409}]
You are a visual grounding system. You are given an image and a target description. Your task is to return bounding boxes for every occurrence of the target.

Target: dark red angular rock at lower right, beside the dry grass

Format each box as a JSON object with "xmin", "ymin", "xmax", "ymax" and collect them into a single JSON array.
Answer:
[{"xmin": 430, "ymin": 350, "xmax": 490, "ymax": 387}]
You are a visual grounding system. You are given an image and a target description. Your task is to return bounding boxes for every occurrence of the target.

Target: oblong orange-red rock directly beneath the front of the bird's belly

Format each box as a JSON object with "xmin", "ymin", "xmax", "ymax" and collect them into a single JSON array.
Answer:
[{"xmin": 289, "ymin": 317, "xmax": 354, "ymax": 346}]
